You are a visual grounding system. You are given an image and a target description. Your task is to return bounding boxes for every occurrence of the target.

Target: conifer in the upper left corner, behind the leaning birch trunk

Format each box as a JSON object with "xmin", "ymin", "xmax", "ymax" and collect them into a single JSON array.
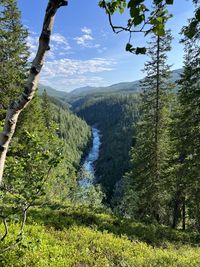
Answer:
[{"xmin": 0, "ymin": 0, "xmax": 29, "ymax": 119}]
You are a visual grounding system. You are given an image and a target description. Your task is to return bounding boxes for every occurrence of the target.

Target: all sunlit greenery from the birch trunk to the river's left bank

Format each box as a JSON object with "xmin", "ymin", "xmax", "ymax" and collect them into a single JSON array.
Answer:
[{"xmin": 1, "ymin": 89, "xmax": 91, "ymax": 213}]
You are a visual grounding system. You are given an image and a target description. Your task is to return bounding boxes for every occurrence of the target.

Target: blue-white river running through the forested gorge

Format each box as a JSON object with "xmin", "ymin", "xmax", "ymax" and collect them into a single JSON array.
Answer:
[{"xmin": 79, "ymin": 127, "xmax": 101, "ymax": 187}]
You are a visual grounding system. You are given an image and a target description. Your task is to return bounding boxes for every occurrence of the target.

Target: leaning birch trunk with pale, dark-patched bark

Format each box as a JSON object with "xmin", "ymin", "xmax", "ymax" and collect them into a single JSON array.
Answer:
[{"xmin": 0, "ymin": 0, "xmax": 67, "ymax": 184}]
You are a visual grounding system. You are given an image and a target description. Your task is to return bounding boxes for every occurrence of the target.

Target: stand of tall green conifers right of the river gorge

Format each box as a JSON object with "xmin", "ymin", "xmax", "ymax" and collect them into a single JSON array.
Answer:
[{"xmin": 118, "ymin": 5, "xmax": 200, "ymax": 231}]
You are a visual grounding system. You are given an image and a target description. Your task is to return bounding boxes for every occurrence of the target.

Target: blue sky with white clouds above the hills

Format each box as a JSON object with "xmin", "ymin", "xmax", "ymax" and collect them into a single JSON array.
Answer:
[{"xmin": 17, "ymin": 0, "xmax": 194, "ymax": 92}]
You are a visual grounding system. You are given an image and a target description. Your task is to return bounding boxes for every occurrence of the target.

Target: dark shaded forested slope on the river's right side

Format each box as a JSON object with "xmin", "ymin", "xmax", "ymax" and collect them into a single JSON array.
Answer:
[{"xmin": 77, "ymin": 94, "xmax": 138, "ymax": 203}]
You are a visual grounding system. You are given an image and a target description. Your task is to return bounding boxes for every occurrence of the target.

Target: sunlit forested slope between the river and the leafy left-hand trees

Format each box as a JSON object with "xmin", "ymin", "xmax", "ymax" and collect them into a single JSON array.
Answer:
[{"xmin": 44, "ymin": 93, "xmax": 91, "ymax": 201}]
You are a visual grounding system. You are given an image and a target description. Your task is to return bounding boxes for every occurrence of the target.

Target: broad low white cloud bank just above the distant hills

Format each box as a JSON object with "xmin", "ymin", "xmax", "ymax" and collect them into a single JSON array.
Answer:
[{"xmin": 41, "ymin": 58, "xmax": 115, "ymax": 91}]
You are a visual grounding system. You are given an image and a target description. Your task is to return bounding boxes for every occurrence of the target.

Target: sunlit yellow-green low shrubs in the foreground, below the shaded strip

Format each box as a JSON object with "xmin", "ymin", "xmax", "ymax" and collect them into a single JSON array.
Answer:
[{"xmin": 0, "ymin": 224, "xmax": 200, "ymax": 267}]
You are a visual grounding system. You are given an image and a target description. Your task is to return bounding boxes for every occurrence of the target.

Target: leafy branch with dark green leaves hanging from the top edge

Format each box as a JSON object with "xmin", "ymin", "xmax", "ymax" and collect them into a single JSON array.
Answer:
[{"xmin": 99, "ymin": 0, "xmax": 173, "ymax": 55}]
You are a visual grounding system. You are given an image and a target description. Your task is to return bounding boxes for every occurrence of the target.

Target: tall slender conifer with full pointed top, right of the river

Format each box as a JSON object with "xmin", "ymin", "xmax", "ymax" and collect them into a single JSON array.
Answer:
[{"xmin": 122, "ymin": 32, "xmax": 172, "ymax": 222}]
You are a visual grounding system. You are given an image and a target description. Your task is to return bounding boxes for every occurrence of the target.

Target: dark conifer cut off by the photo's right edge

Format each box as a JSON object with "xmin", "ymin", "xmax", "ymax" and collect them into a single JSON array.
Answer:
[{"xmin": 173, "ymin": 3, "xmax": 200, "ymax": 230}]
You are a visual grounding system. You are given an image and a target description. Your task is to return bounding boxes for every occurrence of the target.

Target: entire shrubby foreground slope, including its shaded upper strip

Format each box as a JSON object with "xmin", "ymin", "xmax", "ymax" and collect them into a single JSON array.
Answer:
[{"xmin": 0, "ymin": 207, "xmax": 200, "ymax": 267}]
